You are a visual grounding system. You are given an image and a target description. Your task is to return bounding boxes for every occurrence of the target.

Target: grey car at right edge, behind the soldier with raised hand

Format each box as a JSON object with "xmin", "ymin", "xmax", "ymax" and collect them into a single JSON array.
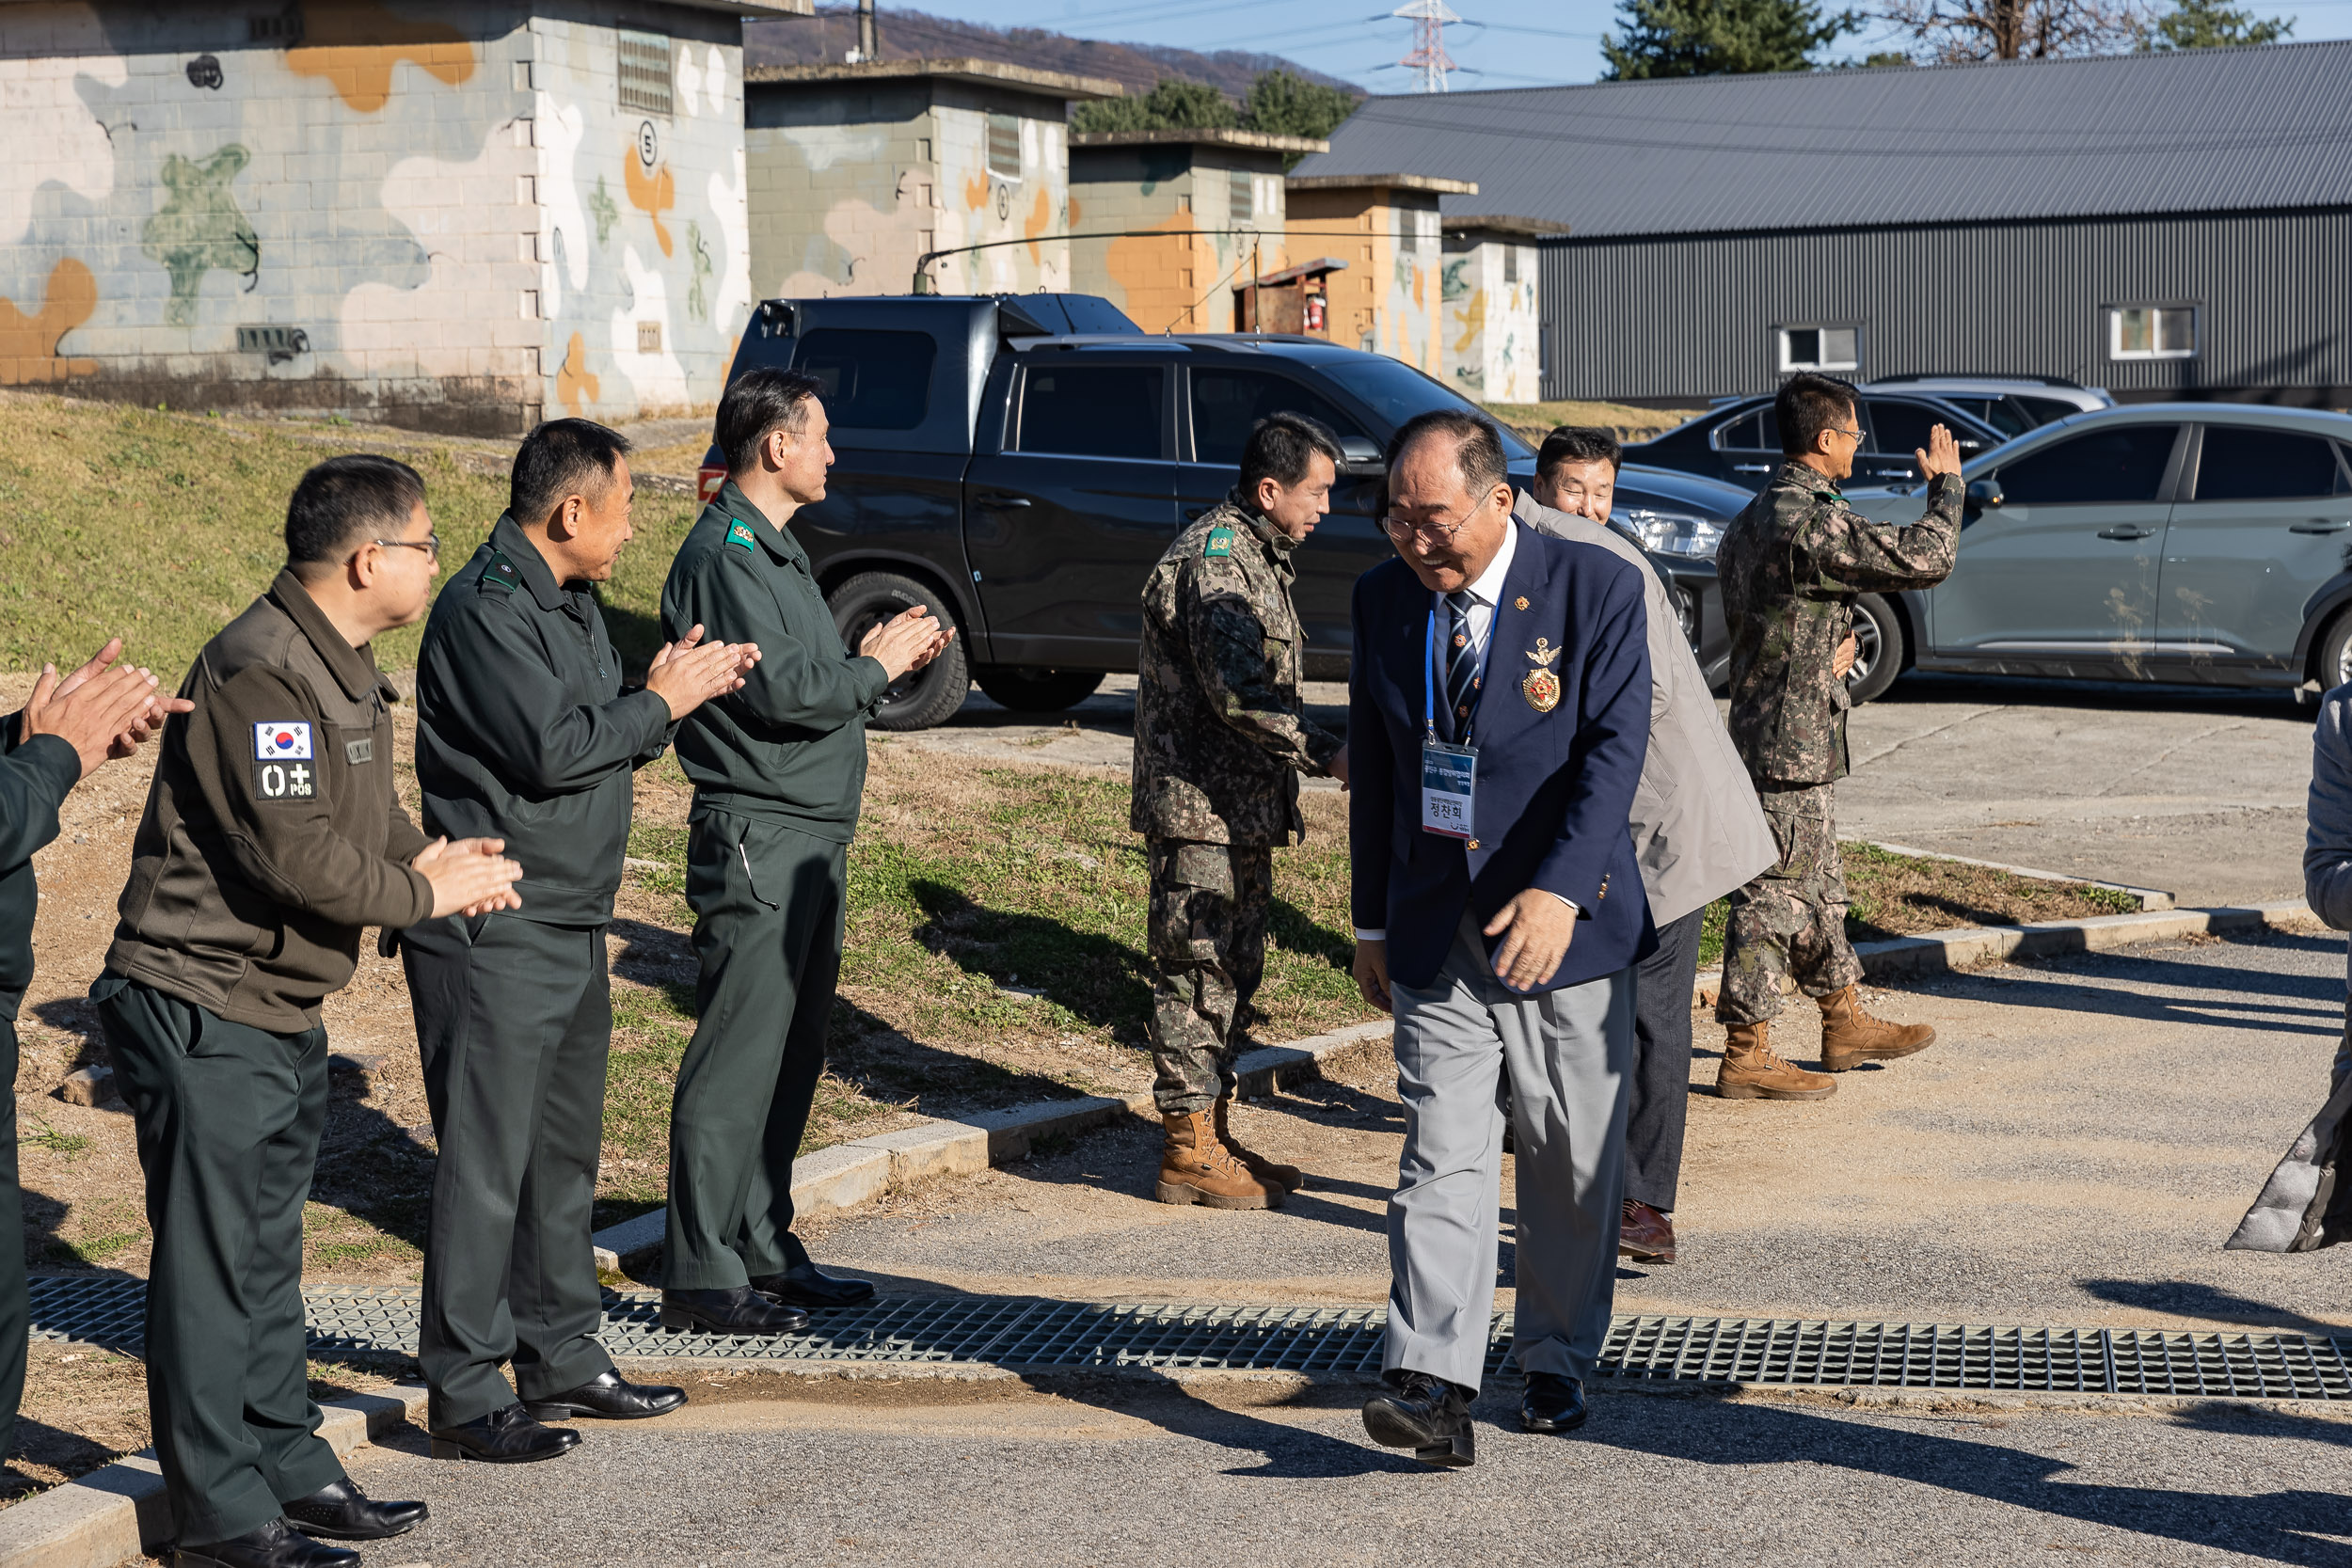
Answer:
[{"xmin": 1849, "ymin": 402, "xmax": 2352, "ymax": 696}]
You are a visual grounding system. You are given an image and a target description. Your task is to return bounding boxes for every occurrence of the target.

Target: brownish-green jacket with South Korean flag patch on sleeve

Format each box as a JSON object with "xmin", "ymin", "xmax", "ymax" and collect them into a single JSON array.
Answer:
[{"xmin": 106, "ymin": 571, "xmax": 433, "ymax": 1035}]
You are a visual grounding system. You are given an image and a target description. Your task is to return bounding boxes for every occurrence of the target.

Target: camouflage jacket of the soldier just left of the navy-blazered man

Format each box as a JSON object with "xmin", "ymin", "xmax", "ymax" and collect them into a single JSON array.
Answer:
[{"xmin": 1129, "ymin": 496, "xmax": 1341, "ymax": 847}]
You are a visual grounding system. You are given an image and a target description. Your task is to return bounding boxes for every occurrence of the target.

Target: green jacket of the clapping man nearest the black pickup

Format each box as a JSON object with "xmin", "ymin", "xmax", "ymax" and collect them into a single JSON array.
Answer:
[{"xmin": 661, "ymin": 480, "xmax": 889, "ymax": 844}]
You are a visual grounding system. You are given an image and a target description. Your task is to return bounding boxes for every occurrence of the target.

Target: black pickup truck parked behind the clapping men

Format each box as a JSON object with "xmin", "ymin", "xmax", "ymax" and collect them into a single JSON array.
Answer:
[{"xmin": 701, "ymin": 293, "xmax": 1745, "ymax": 729}]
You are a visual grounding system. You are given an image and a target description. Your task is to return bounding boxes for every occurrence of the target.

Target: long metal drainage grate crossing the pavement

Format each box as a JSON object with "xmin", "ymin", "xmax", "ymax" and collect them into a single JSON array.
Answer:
[{"xmin": 31, "ymin": 1276, "xmax": 2352, "ymax": 1402}]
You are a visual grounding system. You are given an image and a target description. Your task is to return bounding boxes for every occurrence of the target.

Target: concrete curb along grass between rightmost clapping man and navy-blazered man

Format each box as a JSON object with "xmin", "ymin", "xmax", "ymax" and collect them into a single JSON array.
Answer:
[{"xmin": 593, "ymin": 1021, "xmax": 1391, "ymax": 1278}]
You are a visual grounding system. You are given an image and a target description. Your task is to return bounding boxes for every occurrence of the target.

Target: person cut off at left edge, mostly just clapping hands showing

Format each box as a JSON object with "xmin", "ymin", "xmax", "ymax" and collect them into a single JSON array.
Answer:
[{"xmin": 0, "ymin": 637, "xmax": 188, "ymax": 1455}]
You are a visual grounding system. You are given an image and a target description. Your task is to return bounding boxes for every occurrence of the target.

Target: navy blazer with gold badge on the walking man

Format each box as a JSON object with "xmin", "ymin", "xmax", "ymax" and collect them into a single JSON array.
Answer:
[{"xmin": 1348, "ymin": 519, "xmax": 1659, "ymax": 992}]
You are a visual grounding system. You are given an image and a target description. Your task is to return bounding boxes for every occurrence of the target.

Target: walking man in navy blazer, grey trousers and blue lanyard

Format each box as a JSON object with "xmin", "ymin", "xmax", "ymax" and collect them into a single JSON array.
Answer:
[{"xmin": 1348, "ymin": 411, "xmax": 1656, "ymax": 1465}]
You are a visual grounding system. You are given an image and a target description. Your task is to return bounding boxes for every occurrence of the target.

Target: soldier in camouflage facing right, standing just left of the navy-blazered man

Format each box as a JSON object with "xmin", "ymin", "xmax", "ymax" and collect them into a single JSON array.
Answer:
[{"xmin": 1132, "ymin": 414, "xmax": 1348, "ymax": 1209}]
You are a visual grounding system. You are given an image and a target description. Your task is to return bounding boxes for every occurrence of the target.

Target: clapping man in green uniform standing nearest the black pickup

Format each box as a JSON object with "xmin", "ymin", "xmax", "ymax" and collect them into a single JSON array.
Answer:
[{"xmin": 661, "ymin": 369, "xmax": 953, "ymax": 1336}]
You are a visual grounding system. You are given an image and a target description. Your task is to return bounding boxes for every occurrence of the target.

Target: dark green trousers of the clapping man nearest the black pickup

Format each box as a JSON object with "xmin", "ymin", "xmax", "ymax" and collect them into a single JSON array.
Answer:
[{"xmin": 663, "ymin": 811, "xmax": 850, "ymax": 1291}]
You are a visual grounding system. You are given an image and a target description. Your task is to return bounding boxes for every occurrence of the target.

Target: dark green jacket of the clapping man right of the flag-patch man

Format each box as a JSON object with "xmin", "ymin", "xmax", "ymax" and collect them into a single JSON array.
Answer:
[{"xmin": 417, "ymin": 515, "xmax": 671, "ymax": 927}]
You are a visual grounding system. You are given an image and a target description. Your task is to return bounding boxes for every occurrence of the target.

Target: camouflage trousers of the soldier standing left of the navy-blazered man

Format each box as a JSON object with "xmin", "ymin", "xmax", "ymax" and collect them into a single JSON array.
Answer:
[{"xmin": 1151, "ymin": 839, "xmax": 1275, "ymax": 1117}]
